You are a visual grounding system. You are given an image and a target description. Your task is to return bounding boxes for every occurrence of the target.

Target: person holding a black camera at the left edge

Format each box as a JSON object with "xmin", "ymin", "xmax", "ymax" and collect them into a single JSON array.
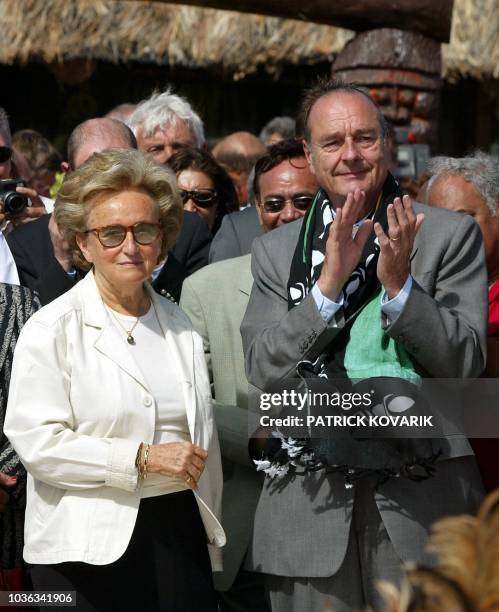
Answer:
[{"xmin": 0, "ymin": 106, "xmax": 47, "ymax": 232}]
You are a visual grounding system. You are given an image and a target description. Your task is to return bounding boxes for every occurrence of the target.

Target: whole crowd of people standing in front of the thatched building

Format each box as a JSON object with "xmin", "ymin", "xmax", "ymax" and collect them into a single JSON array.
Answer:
[{"xmin": 0, "ymin": 79, "xmax": 499, "ymax": 612}]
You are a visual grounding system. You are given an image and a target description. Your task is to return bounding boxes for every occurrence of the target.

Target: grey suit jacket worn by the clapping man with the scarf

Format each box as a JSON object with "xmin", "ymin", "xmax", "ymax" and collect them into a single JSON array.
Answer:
[{"xmin": 241, "ymin": 204, "xmax": 487, "ymax": 577}]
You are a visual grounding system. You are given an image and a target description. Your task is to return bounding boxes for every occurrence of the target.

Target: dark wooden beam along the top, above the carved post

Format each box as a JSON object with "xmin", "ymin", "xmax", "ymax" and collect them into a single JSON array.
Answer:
[{"xmin": 146, "ymin": 0, "xmax": 454, "ymax": 42}]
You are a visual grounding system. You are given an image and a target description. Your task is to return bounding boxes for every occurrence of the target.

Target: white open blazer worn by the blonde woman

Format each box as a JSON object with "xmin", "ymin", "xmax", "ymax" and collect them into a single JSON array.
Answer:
[{"xmin": 4, "ymin": 272, "xmax": 225, "ymax": 570}]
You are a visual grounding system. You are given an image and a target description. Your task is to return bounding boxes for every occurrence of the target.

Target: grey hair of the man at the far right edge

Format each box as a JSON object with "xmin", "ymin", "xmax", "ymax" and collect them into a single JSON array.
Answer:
[{"xmin": 426, "ymin": 151, "xmax": 499, "ymax": 217}]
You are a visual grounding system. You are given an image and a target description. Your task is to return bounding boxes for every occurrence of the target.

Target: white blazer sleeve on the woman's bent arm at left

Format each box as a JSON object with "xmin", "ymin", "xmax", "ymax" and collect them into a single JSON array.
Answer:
[{"xmin": 4, "ymin": 319, "xmax": 138, "ymax": 491}]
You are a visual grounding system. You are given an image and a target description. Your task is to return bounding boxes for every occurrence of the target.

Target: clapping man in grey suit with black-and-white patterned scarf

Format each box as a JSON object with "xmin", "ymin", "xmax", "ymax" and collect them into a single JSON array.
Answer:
[{"xmin": 241, "ymin": 80, "xmax": 487, "ymax": 612}]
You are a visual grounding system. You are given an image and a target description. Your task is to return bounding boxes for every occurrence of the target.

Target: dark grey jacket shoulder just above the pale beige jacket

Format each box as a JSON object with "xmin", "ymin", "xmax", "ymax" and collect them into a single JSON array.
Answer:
[{"xmin": 209, "ymin": 206, "xmax": 263, "ymax": 263}]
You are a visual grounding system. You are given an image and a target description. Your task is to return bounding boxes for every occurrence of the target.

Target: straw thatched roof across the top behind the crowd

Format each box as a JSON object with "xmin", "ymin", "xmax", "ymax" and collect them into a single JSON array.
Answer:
[{"xmin": 0, "ymin": 0, "xmax": 499, "ymax": 78}]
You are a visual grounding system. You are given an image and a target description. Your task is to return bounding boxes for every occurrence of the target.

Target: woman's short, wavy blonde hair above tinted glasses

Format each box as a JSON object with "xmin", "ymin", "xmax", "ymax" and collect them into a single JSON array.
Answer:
[{"xmin": 54, "ymin": 149, "xmax": 183, "ymax": 270}]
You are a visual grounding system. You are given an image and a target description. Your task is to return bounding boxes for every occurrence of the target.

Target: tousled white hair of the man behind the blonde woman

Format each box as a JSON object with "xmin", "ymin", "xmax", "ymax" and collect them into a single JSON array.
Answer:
[{"xmin": 131, "ymin": 89, "xmax": 205, "ymax": 147}]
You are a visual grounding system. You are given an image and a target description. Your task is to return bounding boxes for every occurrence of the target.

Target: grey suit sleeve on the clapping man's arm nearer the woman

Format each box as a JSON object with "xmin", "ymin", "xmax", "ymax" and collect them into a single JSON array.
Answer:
[{"xmin": 241, "ymin": 238, "xmax": 344, "ymax": 390}]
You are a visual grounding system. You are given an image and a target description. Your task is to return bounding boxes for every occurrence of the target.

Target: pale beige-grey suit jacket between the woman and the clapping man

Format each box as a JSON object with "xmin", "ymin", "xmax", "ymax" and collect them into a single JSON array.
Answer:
[{"xmin": 180, "ymin": 255, "xmax": 263, "ymax": 591}]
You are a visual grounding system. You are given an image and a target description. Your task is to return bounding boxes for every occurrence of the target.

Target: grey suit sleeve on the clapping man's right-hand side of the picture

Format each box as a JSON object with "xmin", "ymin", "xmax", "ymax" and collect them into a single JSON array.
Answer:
[{"xmin": 382, "ymin": 215, "xmax": 488, "ymax": 378}]
